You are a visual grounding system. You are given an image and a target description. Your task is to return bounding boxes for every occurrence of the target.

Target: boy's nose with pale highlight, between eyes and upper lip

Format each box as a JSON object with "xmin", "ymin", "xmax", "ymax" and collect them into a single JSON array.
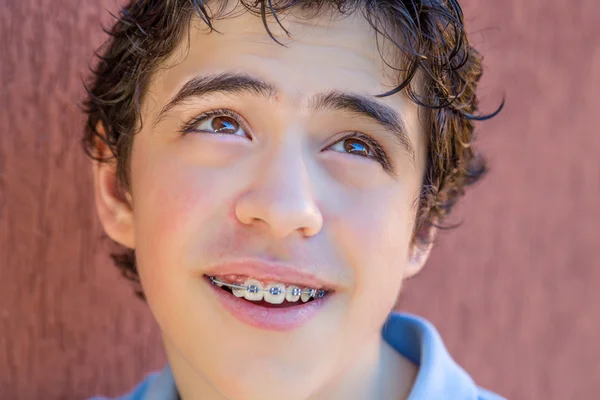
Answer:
[{"xmin": 235, "ymin": 143, "xmax": 323, "ymax": 239}]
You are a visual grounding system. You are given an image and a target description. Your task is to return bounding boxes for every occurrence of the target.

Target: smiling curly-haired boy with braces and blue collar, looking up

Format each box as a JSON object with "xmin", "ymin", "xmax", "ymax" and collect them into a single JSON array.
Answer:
[{"xmin": 84, "ymin": 0, "xmax": 499, "ymax": 400}]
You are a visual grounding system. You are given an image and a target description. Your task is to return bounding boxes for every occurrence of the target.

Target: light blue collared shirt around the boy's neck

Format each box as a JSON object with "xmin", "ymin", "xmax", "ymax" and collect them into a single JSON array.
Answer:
[{"xmin": 90, "ymin": 313, "xmax": 506, "ymax": 400}]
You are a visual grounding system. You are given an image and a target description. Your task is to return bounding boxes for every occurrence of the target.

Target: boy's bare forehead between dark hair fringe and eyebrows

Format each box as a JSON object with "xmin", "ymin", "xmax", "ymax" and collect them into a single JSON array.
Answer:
[{"xmin": 150, "ymin": 7, "xmax": 400, "ymax": 107}]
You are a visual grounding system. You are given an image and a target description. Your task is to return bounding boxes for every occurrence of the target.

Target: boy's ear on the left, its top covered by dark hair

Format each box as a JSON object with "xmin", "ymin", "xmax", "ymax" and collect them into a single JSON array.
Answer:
[{"xmin": 92, "ymin": 122, "xmax": 135, "ymax": 249}]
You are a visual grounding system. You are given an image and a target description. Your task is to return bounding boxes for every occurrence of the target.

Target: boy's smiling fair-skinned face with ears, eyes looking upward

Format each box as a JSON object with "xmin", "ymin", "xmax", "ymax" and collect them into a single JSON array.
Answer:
[{"xmin": 95, "ymin": 6, "xmax": 427, "ymax": 399}]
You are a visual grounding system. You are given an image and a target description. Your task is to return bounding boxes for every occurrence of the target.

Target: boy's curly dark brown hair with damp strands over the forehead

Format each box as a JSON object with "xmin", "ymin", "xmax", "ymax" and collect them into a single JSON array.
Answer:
[{"xmin": 83, "ymin": 0, "xmax": 503, "ymax": 297}]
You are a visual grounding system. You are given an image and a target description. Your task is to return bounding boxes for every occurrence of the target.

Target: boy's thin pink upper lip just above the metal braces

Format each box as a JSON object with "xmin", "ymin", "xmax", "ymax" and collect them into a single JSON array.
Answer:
[{"xmin": 205, "ymin": 260, "xmax": 335, "ymax": 290}]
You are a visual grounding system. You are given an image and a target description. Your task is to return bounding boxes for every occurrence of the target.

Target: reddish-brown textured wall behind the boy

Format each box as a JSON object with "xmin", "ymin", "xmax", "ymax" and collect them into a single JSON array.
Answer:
[{"xmin": 0, "ymin": 0, "xmax": 600, "ymax": 400}]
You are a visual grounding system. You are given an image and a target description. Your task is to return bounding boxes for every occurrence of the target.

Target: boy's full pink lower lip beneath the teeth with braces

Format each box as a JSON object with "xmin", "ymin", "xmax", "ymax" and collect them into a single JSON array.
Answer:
[{"xmin": 207, "ymin": 281, "xmax": 330, "ymax": 331}]
